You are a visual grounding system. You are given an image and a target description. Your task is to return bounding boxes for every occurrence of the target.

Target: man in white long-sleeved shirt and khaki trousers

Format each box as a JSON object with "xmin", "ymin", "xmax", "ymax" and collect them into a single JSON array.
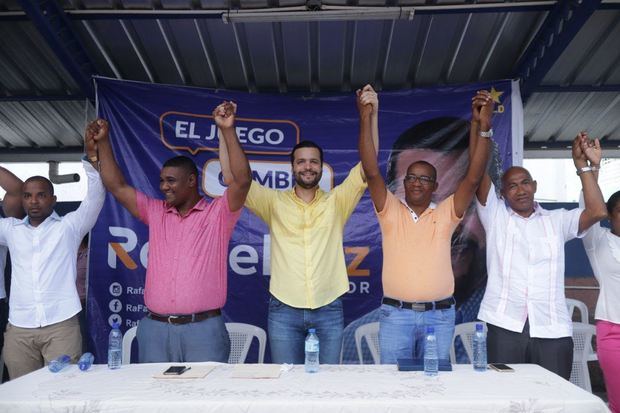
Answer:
[{"xmin": 0, "ymin": 127, "xmax": 105, "ymax": 379}]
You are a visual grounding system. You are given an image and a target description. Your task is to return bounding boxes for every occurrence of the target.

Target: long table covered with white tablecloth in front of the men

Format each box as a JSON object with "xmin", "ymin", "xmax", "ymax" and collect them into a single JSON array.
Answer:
[{"xmin": 0, "ymin": 363, "xmax": 608, "ymax": 413}]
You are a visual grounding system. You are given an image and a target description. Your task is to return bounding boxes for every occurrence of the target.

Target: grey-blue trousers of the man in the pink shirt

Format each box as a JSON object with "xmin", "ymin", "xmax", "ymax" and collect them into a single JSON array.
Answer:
[{"xmin": 136, "ymin": 316, "xmax": 230, "ymax": 363}]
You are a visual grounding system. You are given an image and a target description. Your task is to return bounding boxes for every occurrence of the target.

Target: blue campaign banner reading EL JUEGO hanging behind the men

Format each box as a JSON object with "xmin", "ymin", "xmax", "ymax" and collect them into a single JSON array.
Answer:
[{"xmin": 87, "ymin": 78, "xmax": 523, "ymax": 361}]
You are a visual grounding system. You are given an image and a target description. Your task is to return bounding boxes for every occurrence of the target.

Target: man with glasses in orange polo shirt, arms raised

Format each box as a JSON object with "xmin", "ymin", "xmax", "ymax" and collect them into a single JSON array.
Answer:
[{"xmin": 358, "ymin": 91, "xmax": 493, "ymax": 364}]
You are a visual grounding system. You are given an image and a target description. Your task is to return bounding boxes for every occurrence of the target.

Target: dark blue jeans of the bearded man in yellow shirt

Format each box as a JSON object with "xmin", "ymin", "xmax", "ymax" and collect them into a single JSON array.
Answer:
[{"xmin": 267, "ymin": 296, "xmax": 344, "ymax": 364}]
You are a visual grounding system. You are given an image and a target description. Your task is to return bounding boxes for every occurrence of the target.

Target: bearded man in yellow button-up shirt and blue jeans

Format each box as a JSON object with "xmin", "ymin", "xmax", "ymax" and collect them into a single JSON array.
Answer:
[{"xmin": 220, "ymin": 86, "xmax": 378, "ymax": 364}]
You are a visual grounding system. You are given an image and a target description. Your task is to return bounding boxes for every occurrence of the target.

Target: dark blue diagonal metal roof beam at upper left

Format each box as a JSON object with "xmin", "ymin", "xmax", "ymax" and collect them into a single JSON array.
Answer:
[{"xmin": 19, "ymin": 0, "xmax": 95, "ymax": 101}]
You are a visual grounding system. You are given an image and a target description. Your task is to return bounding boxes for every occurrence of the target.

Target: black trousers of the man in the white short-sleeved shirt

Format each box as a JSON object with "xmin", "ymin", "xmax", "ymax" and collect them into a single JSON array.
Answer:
[{"xmin": 487, "ymin": 320, "xmax": 573, "ymax": 380}]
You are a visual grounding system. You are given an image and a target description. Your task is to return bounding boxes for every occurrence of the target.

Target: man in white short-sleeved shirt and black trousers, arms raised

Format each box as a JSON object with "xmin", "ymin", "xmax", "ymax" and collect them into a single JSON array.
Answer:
[{"xmin": 476, "ymin": 134, "xmax": 606, "ymax": 380}]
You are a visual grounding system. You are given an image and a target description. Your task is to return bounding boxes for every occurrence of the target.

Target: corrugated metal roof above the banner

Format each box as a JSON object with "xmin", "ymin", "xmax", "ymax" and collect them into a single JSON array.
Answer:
[{"xmin": 0, "ymin": 0, "xmax": 620, "ymax": 159}]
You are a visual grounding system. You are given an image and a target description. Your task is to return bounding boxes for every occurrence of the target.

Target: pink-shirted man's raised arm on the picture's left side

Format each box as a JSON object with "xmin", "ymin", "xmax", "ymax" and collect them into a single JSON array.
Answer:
[{"xmin": 86, "ymin": 119, "xmax": 140, "ymax": 218}]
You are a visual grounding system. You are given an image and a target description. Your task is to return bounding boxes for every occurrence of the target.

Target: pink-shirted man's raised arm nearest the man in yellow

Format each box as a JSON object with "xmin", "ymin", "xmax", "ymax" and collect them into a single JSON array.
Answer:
[{"xmin": 213, "ymin": 102, "xmax": 252, "ymax": 211}]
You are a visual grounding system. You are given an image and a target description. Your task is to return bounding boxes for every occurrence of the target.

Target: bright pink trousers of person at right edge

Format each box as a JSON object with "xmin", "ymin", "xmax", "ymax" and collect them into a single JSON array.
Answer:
[{"xmin": 596, "ymin": 320, "xmax": 620, "ymax": 413}]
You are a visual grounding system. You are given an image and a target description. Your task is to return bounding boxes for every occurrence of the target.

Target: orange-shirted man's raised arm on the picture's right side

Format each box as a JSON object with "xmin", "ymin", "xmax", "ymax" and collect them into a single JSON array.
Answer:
[{"xmin": 454, "ymin": 90, "xmax": 494, "ymax": 218}]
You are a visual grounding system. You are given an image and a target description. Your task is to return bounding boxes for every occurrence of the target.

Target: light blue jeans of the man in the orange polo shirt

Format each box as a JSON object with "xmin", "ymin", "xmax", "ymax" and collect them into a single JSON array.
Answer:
[{"xmin": 379, "ymin": 304, "xmax": 455, "ymax": 364}]
